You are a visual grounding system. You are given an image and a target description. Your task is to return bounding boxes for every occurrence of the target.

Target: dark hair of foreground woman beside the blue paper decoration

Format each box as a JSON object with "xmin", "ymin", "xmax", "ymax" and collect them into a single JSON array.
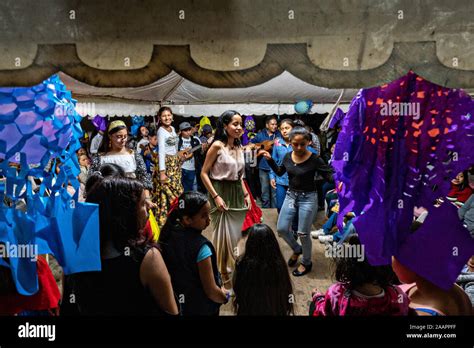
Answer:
[{"xmin": 86, "ymin": 172, "xmax": 146, "ymax": 254}]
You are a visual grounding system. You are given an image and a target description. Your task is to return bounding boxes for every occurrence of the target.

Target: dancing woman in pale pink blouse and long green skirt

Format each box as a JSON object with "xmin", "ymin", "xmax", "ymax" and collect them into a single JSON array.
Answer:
[{"xmin": 201, "ymin": 110, "xmax": 251, "ymax": 288}]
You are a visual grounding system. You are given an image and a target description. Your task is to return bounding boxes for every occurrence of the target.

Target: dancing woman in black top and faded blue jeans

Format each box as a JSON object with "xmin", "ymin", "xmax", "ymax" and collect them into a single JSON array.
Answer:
[{"xmin": 262, "ymin": 127, "xmax": 331, "ymax": 277}]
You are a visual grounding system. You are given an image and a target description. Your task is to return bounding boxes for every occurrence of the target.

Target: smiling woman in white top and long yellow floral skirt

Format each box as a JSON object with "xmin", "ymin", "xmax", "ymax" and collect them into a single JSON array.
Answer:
[{"xmin": 153, "ymin": 106, "xmax": 183, "ymax": 228}]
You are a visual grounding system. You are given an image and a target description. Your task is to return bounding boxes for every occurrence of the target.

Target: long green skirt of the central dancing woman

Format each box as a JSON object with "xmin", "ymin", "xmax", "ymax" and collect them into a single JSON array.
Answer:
[{"xmin": 209, "ymin": 180, "xmax": 248, "ymax": 274}]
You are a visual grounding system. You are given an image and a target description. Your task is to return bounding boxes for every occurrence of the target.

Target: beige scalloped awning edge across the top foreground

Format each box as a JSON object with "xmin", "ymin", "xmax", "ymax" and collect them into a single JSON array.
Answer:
[{"xmin": 0, "ymin": 0, "xmax": 474, "ymax": 88}]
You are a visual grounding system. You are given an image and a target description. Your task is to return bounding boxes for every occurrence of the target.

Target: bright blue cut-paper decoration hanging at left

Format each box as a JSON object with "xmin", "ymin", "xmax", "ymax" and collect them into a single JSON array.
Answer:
[{"xmin": 0, "ymin": 75, "xmax": 101, "ymax": 295}]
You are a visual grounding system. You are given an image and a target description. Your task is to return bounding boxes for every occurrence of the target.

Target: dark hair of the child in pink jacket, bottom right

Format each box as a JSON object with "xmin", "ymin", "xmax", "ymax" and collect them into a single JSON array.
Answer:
[{"xmin": 334, "ymin": 235, "xmax": 396, "ymax": 289}]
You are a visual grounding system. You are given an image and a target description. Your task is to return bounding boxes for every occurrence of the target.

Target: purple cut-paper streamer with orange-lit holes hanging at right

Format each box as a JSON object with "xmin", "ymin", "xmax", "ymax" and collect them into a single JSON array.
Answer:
[{"xmin": 333, "ymin": 72, "xmax": 474, "ymax": 288}]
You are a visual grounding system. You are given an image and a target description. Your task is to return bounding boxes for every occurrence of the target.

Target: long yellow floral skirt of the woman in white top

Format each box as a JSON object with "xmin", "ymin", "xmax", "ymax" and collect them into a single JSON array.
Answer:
[{"xmin": 152, "ymin": 155, "xmax": 183, "ymax": 229}]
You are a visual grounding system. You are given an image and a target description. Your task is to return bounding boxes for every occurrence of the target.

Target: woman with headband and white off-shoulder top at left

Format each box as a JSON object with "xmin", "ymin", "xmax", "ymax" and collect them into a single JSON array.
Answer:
[{"xmin": 89, "ymin": 120, "xmax": 156, "ymax": 209}]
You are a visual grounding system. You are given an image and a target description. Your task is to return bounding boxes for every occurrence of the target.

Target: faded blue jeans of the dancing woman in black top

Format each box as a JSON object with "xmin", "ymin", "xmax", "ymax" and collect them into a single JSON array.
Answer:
[{"xmin": 277, "ymin": 190, "xmax": 318, "ymax": 266}]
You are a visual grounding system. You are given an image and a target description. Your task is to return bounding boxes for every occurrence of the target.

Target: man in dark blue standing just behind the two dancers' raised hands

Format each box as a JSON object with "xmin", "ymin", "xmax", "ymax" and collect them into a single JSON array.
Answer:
[{"xmin": 250, "ymin": 116, "xmax": 282, "ymax": 208}]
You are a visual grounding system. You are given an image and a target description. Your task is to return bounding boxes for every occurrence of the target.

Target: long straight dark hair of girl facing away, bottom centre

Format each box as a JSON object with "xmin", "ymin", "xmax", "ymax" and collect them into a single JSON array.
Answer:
[{"xmin": 233, "ymin": 224, "xmax": 294, "ymax": 315}]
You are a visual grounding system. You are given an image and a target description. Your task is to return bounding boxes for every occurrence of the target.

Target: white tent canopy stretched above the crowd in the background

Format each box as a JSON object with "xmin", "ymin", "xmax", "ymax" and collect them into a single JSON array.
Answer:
[{"xmin": 60, "ymin": 71, "xmax": 357, "ymax": 116}]
